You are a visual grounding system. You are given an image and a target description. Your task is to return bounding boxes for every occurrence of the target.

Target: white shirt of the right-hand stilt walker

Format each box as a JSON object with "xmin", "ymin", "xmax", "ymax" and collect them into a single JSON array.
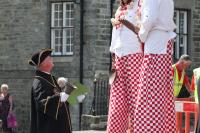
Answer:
[{"xmin": 139, "ymin": 0, "xmax": 176, "ymax": 54}]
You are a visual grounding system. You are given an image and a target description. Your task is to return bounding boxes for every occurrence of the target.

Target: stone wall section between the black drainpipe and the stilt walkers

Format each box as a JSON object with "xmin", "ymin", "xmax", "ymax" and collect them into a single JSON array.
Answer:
[{"xmin": 81, "ymin": 0, "xmax": 110, "ymax": 114}]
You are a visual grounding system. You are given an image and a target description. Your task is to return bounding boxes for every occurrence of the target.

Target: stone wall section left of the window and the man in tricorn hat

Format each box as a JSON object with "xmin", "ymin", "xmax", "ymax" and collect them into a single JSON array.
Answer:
[{"xmin": 0, "ymin": 0, "xmax": 48, "ymax": 133}]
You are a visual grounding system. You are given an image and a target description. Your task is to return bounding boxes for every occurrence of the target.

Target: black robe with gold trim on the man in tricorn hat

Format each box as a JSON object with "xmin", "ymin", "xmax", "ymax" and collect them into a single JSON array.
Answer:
[{"xmin": 31, "ymin": 70, "xmax": 72, "ymax": 133}]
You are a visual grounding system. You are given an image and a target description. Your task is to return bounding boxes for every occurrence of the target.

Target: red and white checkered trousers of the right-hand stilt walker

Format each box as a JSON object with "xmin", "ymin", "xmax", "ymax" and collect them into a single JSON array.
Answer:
[{"xmin": 134, "ymin": 41, "xmax": 176, "ymax": 133}]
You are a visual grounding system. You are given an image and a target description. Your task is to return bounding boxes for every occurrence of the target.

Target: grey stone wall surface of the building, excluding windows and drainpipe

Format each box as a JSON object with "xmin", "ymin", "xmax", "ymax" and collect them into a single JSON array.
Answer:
[{"xmin": 0, "ymin": 0, "xmax": 200, "ymax": 133}]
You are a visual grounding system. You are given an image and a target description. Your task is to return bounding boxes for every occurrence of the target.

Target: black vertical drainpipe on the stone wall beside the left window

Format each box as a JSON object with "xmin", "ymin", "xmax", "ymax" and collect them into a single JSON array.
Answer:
[{"xmin": 79, "ymin": 0, "xmax": 84, "ymax": 130}]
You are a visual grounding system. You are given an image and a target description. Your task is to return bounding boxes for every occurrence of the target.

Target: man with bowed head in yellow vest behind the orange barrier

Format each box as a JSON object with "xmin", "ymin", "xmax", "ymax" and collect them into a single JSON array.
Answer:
[{"xmin": 172, "ymin": 54, "xmax": 193, "ymax": 98}]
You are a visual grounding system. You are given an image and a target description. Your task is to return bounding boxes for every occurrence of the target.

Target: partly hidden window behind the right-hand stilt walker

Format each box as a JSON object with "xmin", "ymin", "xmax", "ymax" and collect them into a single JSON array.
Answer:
[{"xmin": 174, "ymin": 10, "xmax": 188, "ymax": 59}]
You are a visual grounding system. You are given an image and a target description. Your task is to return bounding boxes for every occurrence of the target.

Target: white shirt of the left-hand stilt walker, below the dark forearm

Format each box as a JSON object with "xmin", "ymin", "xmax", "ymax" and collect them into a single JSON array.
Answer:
[{"xmin": 110, "ymin": 0, "xmax": 142, "ymax": 57}]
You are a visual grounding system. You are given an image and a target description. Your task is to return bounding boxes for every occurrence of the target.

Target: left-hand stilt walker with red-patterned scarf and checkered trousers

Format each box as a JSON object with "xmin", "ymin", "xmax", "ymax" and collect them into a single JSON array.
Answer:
[{"xmin": 107, "ymin": 0, "xmax": 143, "ymax": 133}]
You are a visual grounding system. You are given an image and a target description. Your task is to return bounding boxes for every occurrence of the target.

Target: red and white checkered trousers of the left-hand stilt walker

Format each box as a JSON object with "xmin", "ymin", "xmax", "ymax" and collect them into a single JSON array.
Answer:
[{"xmin": 107, "ymin": 53, "xmax": 143, "ymax": 133}]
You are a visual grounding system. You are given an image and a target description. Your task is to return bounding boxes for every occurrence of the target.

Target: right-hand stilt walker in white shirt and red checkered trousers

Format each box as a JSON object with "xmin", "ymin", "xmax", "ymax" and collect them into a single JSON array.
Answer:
[{"xmin": 133, "ymin": 0, "xmax": 176, "ymax": 133}]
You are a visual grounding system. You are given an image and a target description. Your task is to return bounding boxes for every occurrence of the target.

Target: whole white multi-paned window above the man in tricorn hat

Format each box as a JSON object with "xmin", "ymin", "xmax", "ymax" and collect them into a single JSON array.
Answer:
[{"xmin": 51, "ymin": 2, "xmax": 74, "ymax": 55}]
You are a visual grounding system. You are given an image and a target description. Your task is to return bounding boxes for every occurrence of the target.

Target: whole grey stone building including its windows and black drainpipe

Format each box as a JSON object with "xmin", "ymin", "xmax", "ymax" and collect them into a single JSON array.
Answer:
[{"xmin": 0, "ymin": 0, "xmax": 200, "ymax": 133}]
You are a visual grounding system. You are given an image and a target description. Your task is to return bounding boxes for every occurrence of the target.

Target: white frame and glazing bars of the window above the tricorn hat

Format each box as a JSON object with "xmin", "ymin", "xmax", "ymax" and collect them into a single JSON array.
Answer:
[{"xmin": 50, "ymin": 1, "xmax": 75, "ymax": 56}]
